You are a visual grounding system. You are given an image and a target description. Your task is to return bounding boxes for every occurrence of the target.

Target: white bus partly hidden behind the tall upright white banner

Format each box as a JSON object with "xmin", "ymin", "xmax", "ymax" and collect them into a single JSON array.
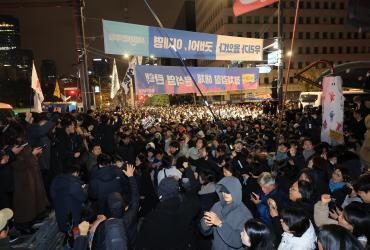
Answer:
[{"xmin": 299, "ymin": 90, "xmax": 370, "ymax": 108}]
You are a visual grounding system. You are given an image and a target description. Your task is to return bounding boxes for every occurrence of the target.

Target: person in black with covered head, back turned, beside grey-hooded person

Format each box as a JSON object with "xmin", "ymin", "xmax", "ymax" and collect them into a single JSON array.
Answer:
[{"xmin": 136, "ymin": 177, "xmax": 199, "ymax": 250}]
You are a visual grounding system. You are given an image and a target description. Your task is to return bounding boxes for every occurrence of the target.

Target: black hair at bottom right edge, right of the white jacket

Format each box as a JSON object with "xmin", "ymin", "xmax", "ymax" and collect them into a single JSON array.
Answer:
[{"xmin": 317, "ymin": 224, "xmax": 364, "ymax": 250}]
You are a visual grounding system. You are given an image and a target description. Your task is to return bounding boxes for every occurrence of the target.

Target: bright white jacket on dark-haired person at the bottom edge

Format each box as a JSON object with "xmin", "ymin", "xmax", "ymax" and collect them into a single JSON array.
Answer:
[{"xmin": 278, "ymin": 222, "xmax": 316, "ymax": 250}]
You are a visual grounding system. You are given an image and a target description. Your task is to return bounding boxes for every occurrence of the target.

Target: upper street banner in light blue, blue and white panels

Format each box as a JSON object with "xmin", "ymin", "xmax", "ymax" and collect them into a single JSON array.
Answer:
[{"xmin": 103, "ymin": 20, "xmax": 263, "ymax": 61}]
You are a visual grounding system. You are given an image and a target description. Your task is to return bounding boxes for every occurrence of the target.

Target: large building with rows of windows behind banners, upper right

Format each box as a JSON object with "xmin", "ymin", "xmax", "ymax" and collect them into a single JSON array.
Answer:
[{"xmin": 195, "ymin": 0, "xmax": 370, "ymax": 99}]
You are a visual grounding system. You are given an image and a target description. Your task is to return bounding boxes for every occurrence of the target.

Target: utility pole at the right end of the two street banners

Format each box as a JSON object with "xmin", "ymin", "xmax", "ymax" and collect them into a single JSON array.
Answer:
[{"xmin": 277, "ymin": 0, "xmax": 284, "ymax": 111}]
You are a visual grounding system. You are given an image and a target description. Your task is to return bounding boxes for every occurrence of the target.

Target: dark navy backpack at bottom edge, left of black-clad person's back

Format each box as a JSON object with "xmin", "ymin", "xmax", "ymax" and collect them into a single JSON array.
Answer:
[{"xmin": 103, "ymin": 219, "xmax": 127, "ymax": 250}]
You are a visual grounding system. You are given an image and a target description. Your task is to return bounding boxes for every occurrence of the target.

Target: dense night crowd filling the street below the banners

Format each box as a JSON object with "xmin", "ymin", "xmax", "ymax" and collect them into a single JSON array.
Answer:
[{"xmin": 0, "ymin": 101, "xmax": 370, "ymax": 250}]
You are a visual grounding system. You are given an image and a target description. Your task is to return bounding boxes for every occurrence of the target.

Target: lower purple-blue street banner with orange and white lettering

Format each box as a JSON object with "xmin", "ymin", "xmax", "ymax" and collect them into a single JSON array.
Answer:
[{"xmin": 135, "ymin": 65, "xmax": 259, "ymax": 95}]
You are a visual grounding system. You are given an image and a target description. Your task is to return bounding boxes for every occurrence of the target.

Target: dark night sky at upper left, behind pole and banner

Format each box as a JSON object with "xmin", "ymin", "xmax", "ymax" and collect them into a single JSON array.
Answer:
[{"xmin": 0, "ymin": 0, "xmax": 184, "ymax": 75}]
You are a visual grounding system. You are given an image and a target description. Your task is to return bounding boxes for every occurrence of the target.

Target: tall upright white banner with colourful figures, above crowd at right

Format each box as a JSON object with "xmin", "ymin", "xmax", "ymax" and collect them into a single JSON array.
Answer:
[{"xmin": 321, "ymin": 76, "xmax": 344, "ymax": 145}]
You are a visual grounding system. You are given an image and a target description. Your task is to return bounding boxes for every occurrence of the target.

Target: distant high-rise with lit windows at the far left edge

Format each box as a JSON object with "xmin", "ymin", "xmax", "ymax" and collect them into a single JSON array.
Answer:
[{"xmin": 0, "ymin": 15, "xmax": 21, "ymax": 66}]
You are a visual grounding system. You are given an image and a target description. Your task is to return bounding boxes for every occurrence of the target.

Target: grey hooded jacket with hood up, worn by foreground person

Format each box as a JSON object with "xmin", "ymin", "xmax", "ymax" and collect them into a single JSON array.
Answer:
[{"xmin": 201, "ymin": 176, "xmax": 253, "ymax": 250}]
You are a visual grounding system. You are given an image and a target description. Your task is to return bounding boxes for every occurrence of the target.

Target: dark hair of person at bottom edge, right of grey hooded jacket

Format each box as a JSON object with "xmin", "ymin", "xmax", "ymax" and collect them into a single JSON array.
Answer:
[{"xmin": 244, "ymin": 219, "xmax": 275, "ymax": 250}]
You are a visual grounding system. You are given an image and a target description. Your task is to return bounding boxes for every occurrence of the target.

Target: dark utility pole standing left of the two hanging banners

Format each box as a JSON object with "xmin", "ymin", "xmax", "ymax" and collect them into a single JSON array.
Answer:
[{"xmin": 73, "ymin": 0, "xmax": 91, "ymax": 112}]
